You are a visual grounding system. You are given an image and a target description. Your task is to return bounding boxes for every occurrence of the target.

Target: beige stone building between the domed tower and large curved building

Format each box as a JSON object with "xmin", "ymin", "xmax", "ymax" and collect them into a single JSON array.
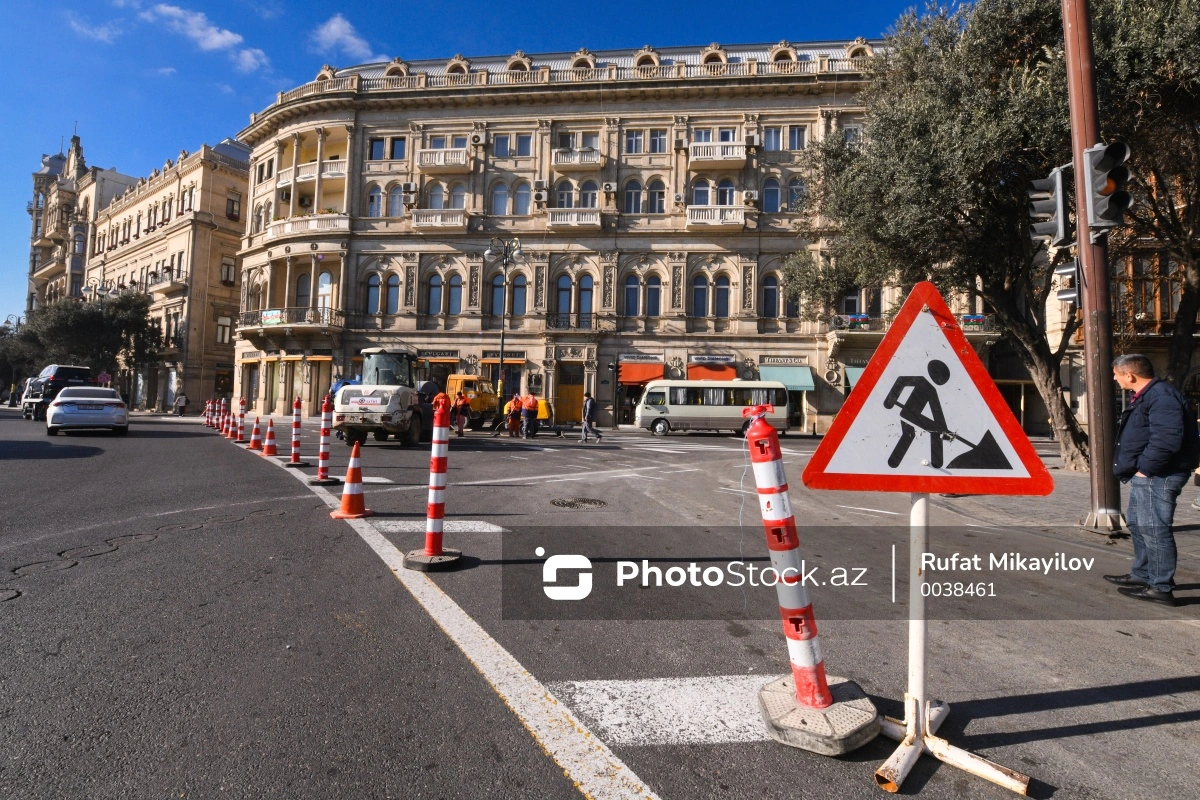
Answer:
[{"xmin": 83, "ymin": 139, "xmax": 250, "ymax": 410}]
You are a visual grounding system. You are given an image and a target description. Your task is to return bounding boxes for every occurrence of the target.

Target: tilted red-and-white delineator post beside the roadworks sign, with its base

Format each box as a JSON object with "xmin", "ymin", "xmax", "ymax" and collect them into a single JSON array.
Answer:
[{"xmin": 742, "ymin": 405, "xmax": 880, "ymax": 756}]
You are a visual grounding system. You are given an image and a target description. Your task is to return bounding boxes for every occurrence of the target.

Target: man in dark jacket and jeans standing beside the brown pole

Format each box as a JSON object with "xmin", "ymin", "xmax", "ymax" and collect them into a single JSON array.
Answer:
[{"xmin": 1104, "ymin": 355, "xmax": 1200, "ymax": 606}]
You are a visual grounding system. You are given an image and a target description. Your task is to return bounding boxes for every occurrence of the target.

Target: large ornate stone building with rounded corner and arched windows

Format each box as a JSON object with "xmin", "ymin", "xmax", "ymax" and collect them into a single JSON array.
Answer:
[{"xmin": 235, "ymin": 40, "xmax": 993, "ymax": 431}]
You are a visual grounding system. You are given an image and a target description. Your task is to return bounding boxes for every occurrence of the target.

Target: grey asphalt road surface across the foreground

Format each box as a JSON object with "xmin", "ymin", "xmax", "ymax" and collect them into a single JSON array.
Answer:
[{"xmin": 0, "ymin": 414, "xmax": 1200, "ymax": 799}]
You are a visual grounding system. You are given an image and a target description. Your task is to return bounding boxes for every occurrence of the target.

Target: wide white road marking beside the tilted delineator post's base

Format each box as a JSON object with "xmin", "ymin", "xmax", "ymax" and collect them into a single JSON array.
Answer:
[{"xmin": 550, "ymin": 675, "xmax": 770, "ymax": 745}]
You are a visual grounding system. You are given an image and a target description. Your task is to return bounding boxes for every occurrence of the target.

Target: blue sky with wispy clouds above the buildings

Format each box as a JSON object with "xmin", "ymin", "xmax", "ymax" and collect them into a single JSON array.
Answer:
[{"xmin": 0, "ymin": 0, "xmax": 913, "ymax": 320}]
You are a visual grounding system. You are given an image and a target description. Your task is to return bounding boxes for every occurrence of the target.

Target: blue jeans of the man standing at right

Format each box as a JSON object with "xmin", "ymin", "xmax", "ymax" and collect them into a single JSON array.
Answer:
[{"xmin": 1126, "ymin": 473, "xmax": 1192, "ymax": 591}]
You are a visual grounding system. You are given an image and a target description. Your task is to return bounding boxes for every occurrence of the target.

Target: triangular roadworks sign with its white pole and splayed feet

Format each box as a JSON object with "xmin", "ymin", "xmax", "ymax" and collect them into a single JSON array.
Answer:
[{"xmin": 803, "ymin": 282, "xmax": 1054, "ymax": 794}]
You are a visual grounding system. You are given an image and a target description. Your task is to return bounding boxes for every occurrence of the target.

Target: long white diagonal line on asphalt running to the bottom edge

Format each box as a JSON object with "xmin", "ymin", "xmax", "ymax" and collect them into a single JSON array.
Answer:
[{"xmin": 271, "ymin": 467, "xmax": 660, "ymax": 800}]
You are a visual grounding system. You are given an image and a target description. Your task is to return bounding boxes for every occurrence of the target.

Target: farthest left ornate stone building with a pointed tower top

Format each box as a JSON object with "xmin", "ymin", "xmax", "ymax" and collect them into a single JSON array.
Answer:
[{"xmin": 25, "ymin": 136, "xmax": 137, "ymax": 311}]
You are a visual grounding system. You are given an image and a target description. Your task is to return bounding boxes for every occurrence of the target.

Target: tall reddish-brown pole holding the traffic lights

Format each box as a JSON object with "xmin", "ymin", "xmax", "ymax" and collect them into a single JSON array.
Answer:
[{"xmin": 1062, "ymin": 0, "xmax": 1124, "ymax": 533}]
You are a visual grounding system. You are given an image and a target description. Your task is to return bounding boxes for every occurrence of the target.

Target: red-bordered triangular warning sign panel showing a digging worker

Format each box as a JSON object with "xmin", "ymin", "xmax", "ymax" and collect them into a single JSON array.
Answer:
[{"xmin": 803, "ymin": 282, "xmax": 1054, "ymax": 494}]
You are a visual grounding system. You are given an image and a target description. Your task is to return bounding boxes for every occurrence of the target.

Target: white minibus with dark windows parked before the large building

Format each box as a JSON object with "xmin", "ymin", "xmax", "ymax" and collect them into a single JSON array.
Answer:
[{"xmin": 634, "ymin": 380, "xmax": 787, "ymax": 437}]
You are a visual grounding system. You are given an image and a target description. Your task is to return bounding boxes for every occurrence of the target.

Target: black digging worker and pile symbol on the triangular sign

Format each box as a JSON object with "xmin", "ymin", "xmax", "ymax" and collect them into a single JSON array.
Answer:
[{"xmin": 883, "ymin": 359, "xmax": 1012, "ymax": 469}]
